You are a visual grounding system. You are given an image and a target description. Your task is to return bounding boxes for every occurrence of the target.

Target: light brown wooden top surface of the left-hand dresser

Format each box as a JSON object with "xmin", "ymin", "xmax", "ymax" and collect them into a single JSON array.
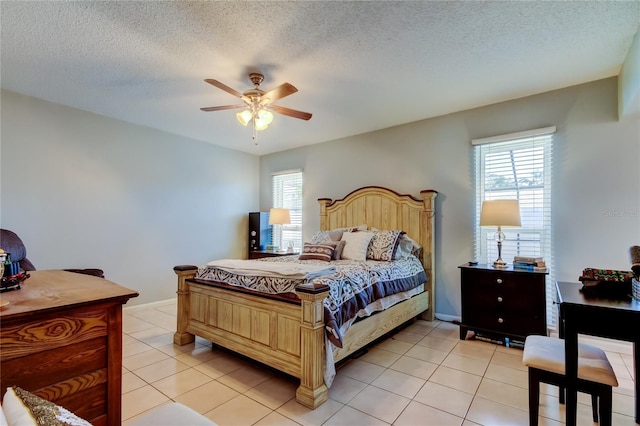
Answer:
[{"xmin": 0, "ymin": 270, "xmax": 138, "ymax": 320}]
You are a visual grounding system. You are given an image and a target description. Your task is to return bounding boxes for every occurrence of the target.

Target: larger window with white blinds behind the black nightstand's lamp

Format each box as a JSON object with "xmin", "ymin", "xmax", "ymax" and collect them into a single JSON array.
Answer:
[{"xmin": 472, "ymin": 127, "xmax": 555, "ymax": 327}]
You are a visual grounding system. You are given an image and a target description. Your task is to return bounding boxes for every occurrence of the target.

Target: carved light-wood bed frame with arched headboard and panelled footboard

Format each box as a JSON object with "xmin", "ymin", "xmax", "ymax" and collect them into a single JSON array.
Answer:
[{"xmin": 173, "ymin": 186, "xmax": 437, "ymax": 409}]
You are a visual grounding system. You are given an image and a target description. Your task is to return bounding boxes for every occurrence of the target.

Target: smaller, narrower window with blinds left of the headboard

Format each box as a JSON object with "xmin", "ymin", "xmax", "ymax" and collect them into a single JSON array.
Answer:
[{"xmin": 271, "ymin": 170, "xmax": 302, "ymax": 249}]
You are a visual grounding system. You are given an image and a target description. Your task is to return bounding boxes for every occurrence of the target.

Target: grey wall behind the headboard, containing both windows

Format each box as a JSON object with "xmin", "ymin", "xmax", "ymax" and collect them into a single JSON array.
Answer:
[{"xmin": 260, "ymin": 78, "xmax": 640, "ymax": 316}]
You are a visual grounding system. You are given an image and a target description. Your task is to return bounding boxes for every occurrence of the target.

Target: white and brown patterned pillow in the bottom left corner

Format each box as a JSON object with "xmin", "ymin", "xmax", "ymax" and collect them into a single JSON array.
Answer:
[{"xmin": 2, "ymin": 387, "xmax": 91, "ymax": 426}]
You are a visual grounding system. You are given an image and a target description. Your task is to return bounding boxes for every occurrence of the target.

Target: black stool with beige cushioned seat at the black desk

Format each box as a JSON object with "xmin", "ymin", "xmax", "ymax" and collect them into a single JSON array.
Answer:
[{"xmin": 522, "ymin": 335, "xmax": 618, "ymax": 426}]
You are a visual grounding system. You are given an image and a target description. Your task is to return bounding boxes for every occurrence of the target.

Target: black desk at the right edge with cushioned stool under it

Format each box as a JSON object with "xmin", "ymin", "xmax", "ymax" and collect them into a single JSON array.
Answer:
[{"xmin": 556, "ymin": 282, "xmax": 640, "ymax": 425}]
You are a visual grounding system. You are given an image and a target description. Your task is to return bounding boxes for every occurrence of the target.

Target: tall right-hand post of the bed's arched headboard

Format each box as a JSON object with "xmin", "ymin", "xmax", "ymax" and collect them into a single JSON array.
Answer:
[{"xmin": 420, "ymin": 189, "xmax": 438, "ymax": 321}]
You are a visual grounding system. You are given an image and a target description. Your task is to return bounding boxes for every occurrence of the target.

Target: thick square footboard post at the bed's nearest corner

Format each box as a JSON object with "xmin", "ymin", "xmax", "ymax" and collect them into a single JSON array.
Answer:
[{"xmin": 296, "ymin": 285, "xmax": 329, "ymax": 410}]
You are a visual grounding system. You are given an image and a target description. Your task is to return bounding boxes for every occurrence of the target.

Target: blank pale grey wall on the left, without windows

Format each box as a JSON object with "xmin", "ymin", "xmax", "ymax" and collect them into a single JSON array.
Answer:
[{"xmin": 0, "ymin": 91, "xmax": 259, "ymax": 304}]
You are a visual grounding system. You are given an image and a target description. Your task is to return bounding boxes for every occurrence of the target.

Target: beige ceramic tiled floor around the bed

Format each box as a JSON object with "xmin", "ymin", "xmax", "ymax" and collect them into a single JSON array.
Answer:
[{"xmin": 122, "ymin": 300, "xmax": 635, "ymax": 426}]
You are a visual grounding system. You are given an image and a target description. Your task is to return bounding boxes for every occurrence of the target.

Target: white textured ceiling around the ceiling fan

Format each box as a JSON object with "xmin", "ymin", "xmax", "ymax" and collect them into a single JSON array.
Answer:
[{"xmin": 0, "ymin": 0, "xmax": 640, "ymax": 155}]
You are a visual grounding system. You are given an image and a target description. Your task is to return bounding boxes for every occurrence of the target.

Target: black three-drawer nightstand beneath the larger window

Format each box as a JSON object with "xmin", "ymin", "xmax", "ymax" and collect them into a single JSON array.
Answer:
[{"xmin": 459, "ymin": 264, "xmax": 547, "ymax": 343}]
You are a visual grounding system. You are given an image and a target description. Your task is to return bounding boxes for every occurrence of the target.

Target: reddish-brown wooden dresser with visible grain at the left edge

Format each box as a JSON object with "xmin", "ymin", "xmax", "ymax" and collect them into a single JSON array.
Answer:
[{"xmin": 0, "ymin": 270, "xmax": 138, "ymax": 426}]
